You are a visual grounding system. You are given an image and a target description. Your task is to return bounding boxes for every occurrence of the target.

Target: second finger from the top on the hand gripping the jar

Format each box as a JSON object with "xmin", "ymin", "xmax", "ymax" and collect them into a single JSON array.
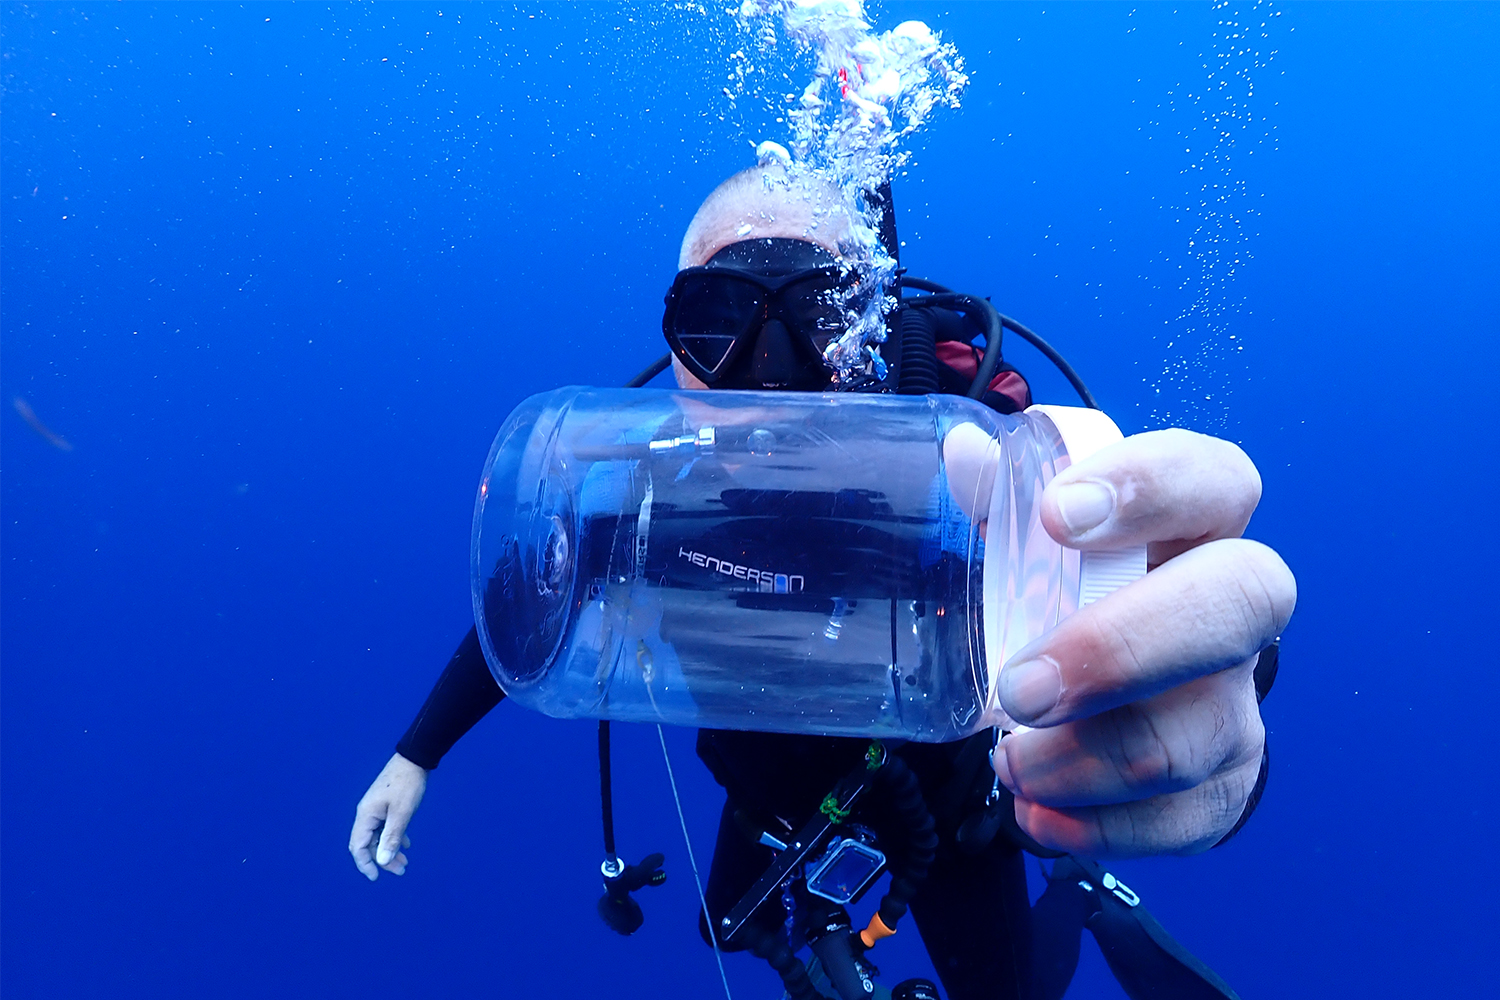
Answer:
[{"xmin": 996, "ymin": 538, "xmax": 1296, "ymax": 726}]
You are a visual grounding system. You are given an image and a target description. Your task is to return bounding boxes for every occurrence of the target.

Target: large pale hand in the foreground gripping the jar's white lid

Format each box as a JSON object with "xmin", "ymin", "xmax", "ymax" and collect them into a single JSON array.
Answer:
[{"xmin": 995, "ymin": 430, "xmax": 1296, "ymax": 858}]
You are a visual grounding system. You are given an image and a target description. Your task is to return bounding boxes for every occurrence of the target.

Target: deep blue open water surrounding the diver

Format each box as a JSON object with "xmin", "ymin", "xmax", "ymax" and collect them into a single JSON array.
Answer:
[{"xmin": 0, "ymin": 3, "xmax": 1500, "ymax": 999}]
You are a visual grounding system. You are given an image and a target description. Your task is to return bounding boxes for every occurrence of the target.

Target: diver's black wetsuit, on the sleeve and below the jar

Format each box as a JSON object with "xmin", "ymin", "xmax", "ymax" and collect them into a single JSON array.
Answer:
[{"xmin": 396, "ymin": 620, "xmax": 1275, "ymax": 1000}]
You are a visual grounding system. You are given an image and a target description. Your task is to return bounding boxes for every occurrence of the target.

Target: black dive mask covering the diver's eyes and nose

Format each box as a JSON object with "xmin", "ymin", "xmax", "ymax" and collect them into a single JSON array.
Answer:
[{"xmin": 662, "ymin": 238, "xmax": 857, "ymax": 391}]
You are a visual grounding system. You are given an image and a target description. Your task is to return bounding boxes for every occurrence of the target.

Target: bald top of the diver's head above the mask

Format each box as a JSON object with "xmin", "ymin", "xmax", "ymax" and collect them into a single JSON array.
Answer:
[{"xmin": 677, "ymin": 163, "xmax": 849, "ymax": 270}]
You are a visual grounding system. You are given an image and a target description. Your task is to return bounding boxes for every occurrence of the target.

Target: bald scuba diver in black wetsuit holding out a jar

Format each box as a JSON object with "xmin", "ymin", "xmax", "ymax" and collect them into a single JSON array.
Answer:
[{"xmin": 350, "ymin": 163, "xmax": 1296, "ymax": 1000}]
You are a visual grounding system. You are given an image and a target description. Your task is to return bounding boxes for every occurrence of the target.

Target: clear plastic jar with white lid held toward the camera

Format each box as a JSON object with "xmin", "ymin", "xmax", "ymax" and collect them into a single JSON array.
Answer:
[{"xmin": 473, "ymin": 387, "xmax": 1146, "ymax": 742}]
